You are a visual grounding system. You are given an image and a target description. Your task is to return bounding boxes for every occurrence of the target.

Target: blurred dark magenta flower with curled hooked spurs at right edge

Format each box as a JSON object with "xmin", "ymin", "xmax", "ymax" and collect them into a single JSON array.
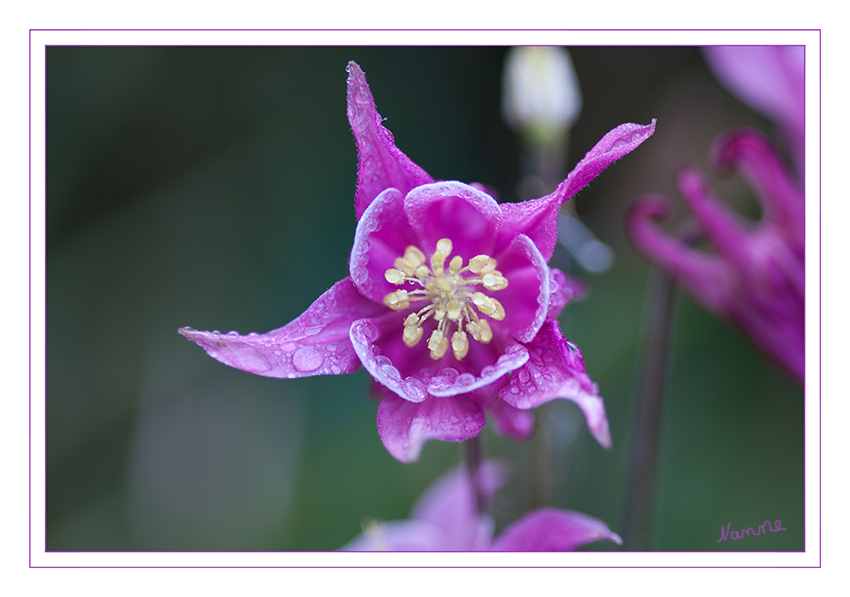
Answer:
[{"xmin": 627, "ymin": 129, "xmax": 805, "ymax": 385}]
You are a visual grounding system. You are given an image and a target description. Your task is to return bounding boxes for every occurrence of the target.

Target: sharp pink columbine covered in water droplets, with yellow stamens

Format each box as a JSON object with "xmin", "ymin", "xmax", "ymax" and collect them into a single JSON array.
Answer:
[{"xmin": 180, "ymin": 62, "xmax": 655, "ymax": 462}]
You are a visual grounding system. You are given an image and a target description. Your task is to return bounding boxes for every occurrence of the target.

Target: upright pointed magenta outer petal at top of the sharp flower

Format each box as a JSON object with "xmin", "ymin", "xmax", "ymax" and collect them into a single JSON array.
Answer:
[{"xmin": 347, "ymin": 62, "xmax": 434, "ymax": 219}]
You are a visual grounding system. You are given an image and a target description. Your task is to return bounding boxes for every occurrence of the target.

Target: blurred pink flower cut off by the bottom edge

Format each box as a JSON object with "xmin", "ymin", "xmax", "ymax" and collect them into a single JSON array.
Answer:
[{"xmin": 342, "ymin": 462, "xmax": 622, "ymax": 551}]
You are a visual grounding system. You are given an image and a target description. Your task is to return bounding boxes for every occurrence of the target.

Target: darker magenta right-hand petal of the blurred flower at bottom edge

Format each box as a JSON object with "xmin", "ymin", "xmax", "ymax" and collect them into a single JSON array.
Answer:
[{"xmin": 490, "ymin": 508, "xmax": 623, "ymax": 551}]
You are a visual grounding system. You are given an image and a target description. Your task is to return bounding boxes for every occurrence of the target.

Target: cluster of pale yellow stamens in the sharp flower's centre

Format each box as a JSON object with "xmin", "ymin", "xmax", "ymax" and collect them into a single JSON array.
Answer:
[{"xmin": 384, "ymin": 238, "xmax": 508, "ymax": 360}]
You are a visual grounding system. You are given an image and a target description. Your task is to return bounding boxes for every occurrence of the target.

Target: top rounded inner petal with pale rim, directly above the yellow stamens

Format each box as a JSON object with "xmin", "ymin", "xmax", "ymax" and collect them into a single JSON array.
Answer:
[{"xmin": 404, "ymin": 180, "xmax": 502, "ymax": 262}]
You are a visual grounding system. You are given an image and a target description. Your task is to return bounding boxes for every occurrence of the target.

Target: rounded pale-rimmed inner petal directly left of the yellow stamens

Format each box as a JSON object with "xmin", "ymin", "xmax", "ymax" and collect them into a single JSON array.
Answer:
[{"xmin": 348, "ymin": 188, "xmax": 417, "ymax": 303}]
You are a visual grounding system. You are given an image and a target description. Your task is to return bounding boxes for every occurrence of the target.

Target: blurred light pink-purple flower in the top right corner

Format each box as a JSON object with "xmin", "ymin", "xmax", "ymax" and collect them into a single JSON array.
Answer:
[{"xmin": 703, "ymin": 46, "xmax": 806, "ymax": 178}]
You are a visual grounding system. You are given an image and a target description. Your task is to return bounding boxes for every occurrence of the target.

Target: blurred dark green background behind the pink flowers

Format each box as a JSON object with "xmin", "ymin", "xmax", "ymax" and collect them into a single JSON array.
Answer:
[{"xmin": 47, "ymin": 47, "xmax": 804, "ymax": 551}]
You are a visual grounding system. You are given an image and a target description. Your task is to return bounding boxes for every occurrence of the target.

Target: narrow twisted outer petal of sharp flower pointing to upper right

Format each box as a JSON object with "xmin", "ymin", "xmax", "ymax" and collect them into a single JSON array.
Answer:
[{"xmin": 497, "ymin": 119, "xmax": 655, "ymax": 261}]
